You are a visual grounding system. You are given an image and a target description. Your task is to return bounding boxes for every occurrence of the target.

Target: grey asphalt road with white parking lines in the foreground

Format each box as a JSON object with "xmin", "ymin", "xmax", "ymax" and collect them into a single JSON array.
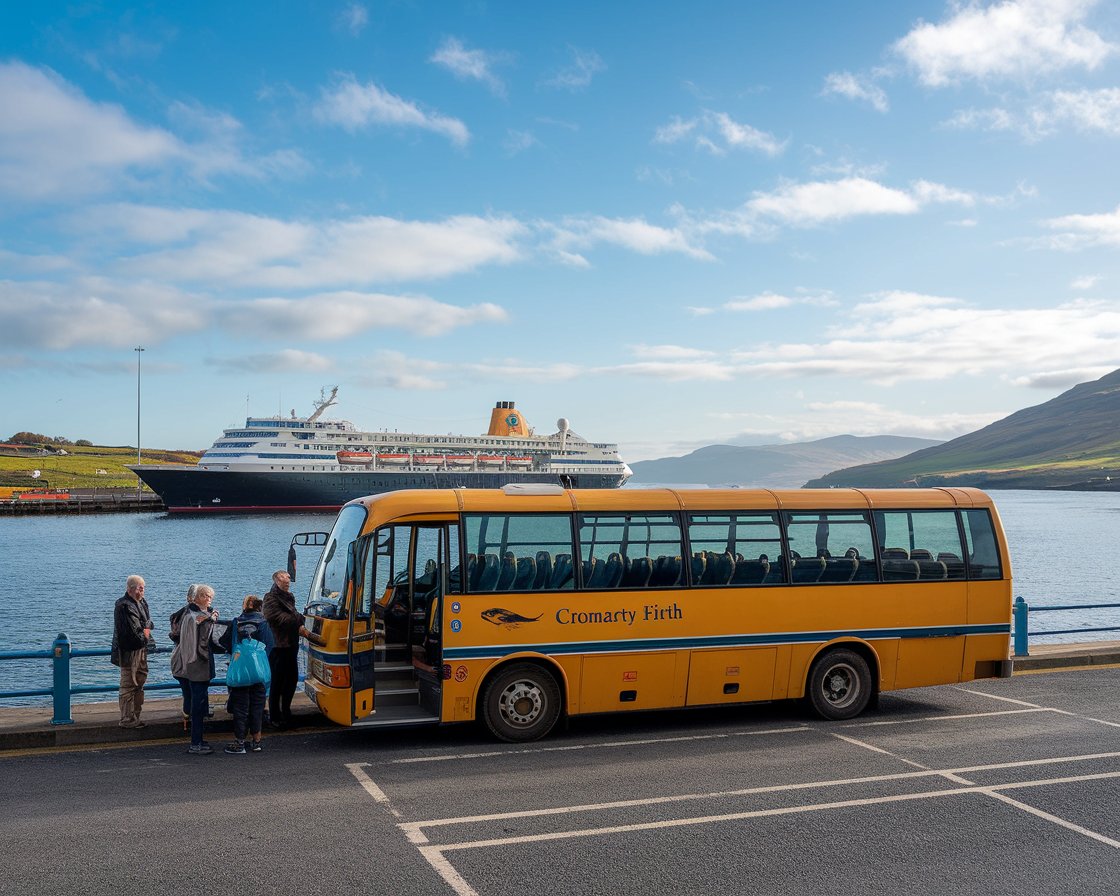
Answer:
[{"xmin": 0, "ymin": 668, "xmax": 1120, "ymax": 896}]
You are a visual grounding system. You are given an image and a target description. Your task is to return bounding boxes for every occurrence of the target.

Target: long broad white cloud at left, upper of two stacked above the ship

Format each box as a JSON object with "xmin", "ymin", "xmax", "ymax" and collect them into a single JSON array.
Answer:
[{"xmin": 81, "ymin": 205, "xmax": 526, "ymax": 289}]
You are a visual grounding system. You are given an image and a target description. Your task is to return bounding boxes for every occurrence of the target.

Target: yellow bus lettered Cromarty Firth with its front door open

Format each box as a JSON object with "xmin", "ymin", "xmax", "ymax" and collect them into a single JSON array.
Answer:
[{"xmin": 289, "ymin": 485, "xmax": 1011, "ymax": 741}]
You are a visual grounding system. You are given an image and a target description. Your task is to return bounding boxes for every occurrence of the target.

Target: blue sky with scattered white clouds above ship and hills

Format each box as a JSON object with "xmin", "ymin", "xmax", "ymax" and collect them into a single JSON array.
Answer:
[{"xmin": 0, "ymin": 0, "xmax": 1120, "ymax": 460}]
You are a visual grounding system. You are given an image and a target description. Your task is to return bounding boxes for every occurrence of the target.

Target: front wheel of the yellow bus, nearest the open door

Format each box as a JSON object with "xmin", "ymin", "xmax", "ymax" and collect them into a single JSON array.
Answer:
[{"xmin": 482, "ymin": 663, "xmax": 560, "ymax": 744}]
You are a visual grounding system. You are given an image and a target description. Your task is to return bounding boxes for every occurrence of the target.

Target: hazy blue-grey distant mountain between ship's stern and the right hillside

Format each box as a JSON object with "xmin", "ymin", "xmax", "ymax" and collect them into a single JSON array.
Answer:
[{"xmin": 631, "ymin": 436, "xmax": 939, "ymax": 488}]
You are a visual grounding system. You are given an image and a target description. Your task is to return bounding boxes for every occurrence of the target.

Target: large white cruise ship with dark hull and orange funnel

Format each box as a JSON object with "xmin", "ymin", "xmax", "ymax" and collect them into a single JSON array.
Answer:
[{"xmin": 129, "ymin": 386, "xmax": 631, "ymax": 513}]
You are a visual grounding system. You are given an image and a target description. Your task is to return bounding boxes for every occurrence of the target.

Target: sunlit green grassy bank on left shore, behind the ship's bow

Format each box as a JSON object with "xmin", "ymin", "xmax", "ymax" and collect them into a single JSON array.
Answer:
[{"xmin": 0, "ymin": 445, "xmax": 198, "ymax": 488}]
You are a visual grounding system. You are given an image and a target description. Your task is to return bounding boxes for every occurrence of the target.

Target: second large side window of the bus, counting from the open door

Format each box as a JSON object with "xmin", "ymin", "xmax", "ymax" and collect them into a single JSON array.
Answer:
[{"xmin": 579, "ymin": 513, "xmax": 685, "ymax": 591}]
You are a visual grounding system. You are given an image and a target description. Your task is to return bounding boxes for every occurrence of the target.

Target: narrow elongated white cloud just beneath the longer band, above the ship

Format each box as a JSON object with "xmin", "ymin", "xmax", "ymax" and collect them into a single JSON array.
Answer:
[{"xmin": 218, "ymin": 291, "xmax": 506, "ymax": 340}]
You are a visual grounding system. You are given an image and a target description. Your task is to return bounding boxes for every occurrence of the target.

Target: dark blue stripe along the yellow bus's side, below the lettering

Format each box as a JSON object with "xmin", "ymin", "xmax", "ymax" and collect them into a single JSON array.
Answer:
[{"xmin": 444, "ymin": 623, "xmax": 1011, "ymax": 660}]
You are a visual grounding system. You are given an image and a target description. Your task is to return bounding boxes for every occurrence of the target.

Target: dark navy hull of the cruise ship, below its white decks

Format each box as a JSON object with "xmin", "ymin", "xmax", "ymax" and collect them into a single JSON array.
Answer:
[{"xmin": 133, "ymin": 466, "xmax": 625, "ymax": 513}]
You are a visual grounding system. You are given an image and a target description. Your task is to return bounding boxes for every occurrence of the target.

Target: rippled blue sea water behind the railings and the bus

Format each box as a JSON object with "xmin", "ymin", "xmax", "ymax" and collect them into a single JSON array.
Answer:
[{"xmin": 0, "ymin": 492, "xmax": 1120, "ymax": 704}]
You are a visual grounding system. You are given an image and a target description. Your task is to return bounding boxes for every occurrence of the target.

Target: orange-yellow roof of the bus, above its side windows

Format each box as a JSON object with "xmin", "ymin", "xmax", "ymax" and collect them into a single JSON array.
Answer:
[{"xmin": 351, "ymin": 486, "xmax": 992, "ymax": 528}]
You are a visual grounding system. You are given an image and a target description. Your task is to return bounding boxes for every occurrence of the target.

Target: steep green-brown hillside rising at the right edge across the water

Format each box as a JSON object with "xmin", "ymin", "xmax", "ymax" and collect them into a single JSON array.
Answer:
[{"xmin": 808, "ymin": 370, "xmax": 1120, "ymax": 491}]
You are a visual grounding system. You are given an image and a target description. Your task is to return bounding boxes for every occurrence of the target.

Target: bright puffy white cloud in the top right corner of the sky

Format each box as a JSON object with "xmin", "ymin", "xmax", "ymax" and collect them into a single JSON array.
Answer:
[{"xmin": 893, "ymin": 0, "xmax": 1116, "ymax": 87}]
